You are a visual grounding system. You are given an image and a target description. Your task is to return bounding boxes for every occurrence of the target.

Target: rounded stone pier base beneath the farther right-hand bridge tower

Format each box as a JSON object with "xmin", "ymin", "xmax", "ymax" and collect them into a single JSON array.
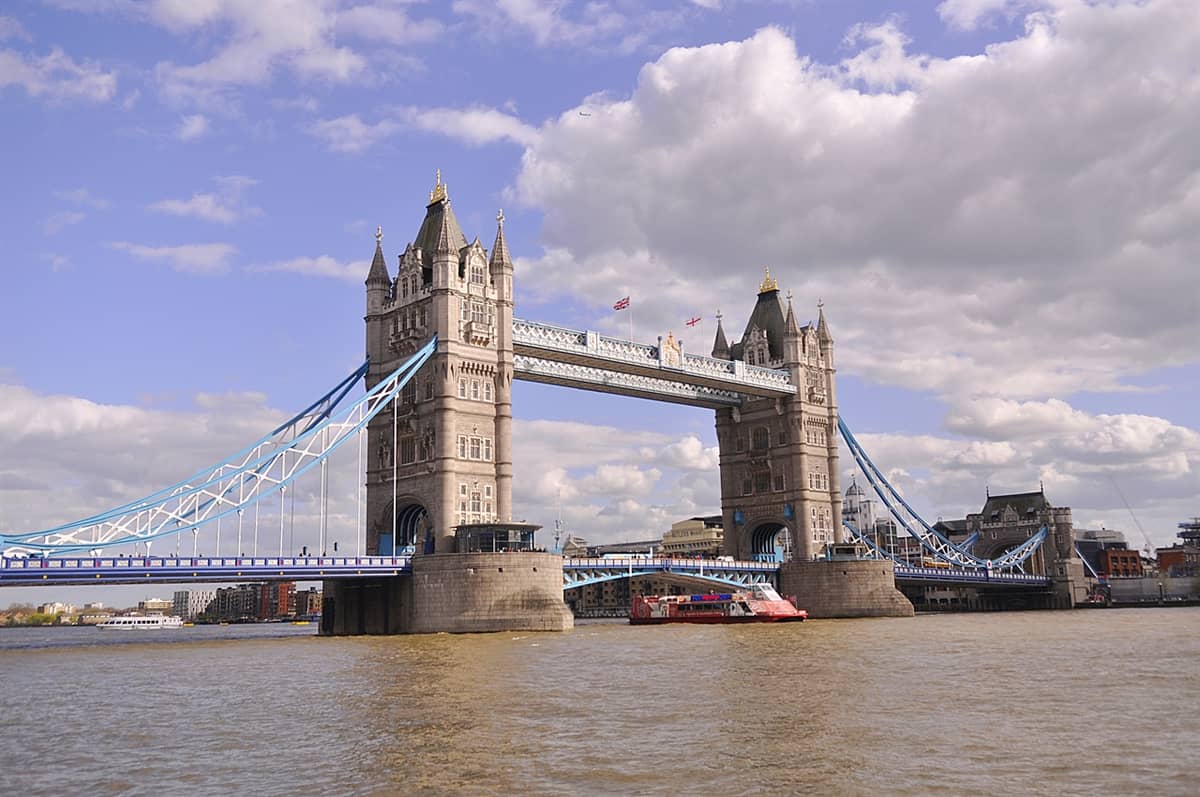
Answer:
[{"xmin": 779, "ymin": 559, "xmax": 913, "ymax": 618}]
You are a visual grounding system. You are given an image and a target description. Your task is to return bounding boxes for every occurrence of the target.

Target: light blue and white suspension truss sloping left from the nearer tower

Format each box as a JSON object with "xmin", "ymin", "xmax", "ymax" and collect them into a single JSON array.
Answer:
[{"xmin": 0, "ymin": 337, "xmax": 437, "ymax": 552}]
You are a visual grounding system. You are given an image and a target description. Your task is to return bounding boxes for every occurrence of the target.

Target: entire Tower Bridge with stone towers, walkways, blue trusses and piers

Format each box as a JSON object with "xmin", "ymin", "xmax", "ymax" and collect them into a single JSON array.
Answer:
[{"xmin": 0, "ymin": 174, "xmax": 1089, "ymax": 634}]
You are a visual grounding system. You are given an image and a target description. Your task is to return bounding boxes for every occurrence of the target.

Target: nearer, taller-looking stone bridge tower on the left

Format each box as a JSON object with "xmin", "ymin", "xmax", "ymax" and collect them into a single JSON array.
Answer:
[{"xmin": 366, "ymin": 173, "xmax": 512, "ymax": 555}]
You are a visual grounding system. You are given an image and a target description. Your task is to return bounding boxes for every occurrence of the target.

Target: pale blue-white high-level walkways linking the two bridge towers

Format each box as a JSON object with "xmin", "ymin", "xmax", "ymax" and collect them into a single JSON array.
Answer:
[{"xmin": 512, "ymin": 318, "xmax": 796, "ymax": 409}]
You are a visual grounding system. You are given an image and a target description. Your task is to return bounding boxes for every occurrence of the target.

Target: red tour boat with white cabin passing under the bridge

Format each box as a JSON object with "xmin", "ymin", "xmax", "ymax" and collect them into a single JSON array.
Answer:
[{"xmin": 629, "ymin": 583, "xmax": 809, "ymax": 625}]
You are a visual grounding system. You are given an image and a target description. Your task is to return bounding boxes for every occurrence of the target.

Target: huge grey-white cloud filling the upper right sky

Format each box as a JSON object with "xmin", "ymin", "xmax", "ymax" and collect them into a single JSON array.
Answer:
[{"xmin": 511, "ymin": 0, "xmax": 1200, "ymax": 399}]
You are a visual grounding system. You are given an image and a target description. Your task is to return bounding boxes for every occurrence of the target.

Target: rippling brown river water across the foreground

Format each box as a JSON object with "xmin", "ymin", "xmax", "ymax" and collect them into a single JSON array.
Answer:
[{"xmin": 0, "ymin": 609, "xmax": 1200, "ymax": 796}]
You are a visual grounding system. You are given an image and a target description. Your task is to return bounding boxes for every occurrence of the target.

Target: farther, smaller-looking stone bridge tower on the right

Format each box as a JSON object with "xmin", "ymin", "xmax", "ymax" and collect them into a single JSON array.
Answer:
[{"xmin": 713, "ymin": 271, "xmax": 841, "ymax": 562}]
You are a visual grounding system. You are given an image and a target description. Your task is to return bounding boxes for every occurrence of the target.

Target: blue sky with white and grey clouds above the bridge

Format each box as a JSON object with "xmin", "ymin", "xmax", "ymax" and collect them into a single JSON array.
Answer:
[{"xmin": 0, "ymin": 0, "xmax": 1200, "ymax": 604}]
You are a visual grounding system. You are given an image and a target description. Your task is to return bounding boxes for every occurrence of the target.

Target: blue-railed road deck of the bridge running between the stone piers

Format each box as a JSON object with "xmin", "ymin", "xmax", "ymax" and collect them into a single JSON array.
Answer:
[{"xmin": 0, "ymin": 556, "xmax": 1050, "ymax": 589}]
